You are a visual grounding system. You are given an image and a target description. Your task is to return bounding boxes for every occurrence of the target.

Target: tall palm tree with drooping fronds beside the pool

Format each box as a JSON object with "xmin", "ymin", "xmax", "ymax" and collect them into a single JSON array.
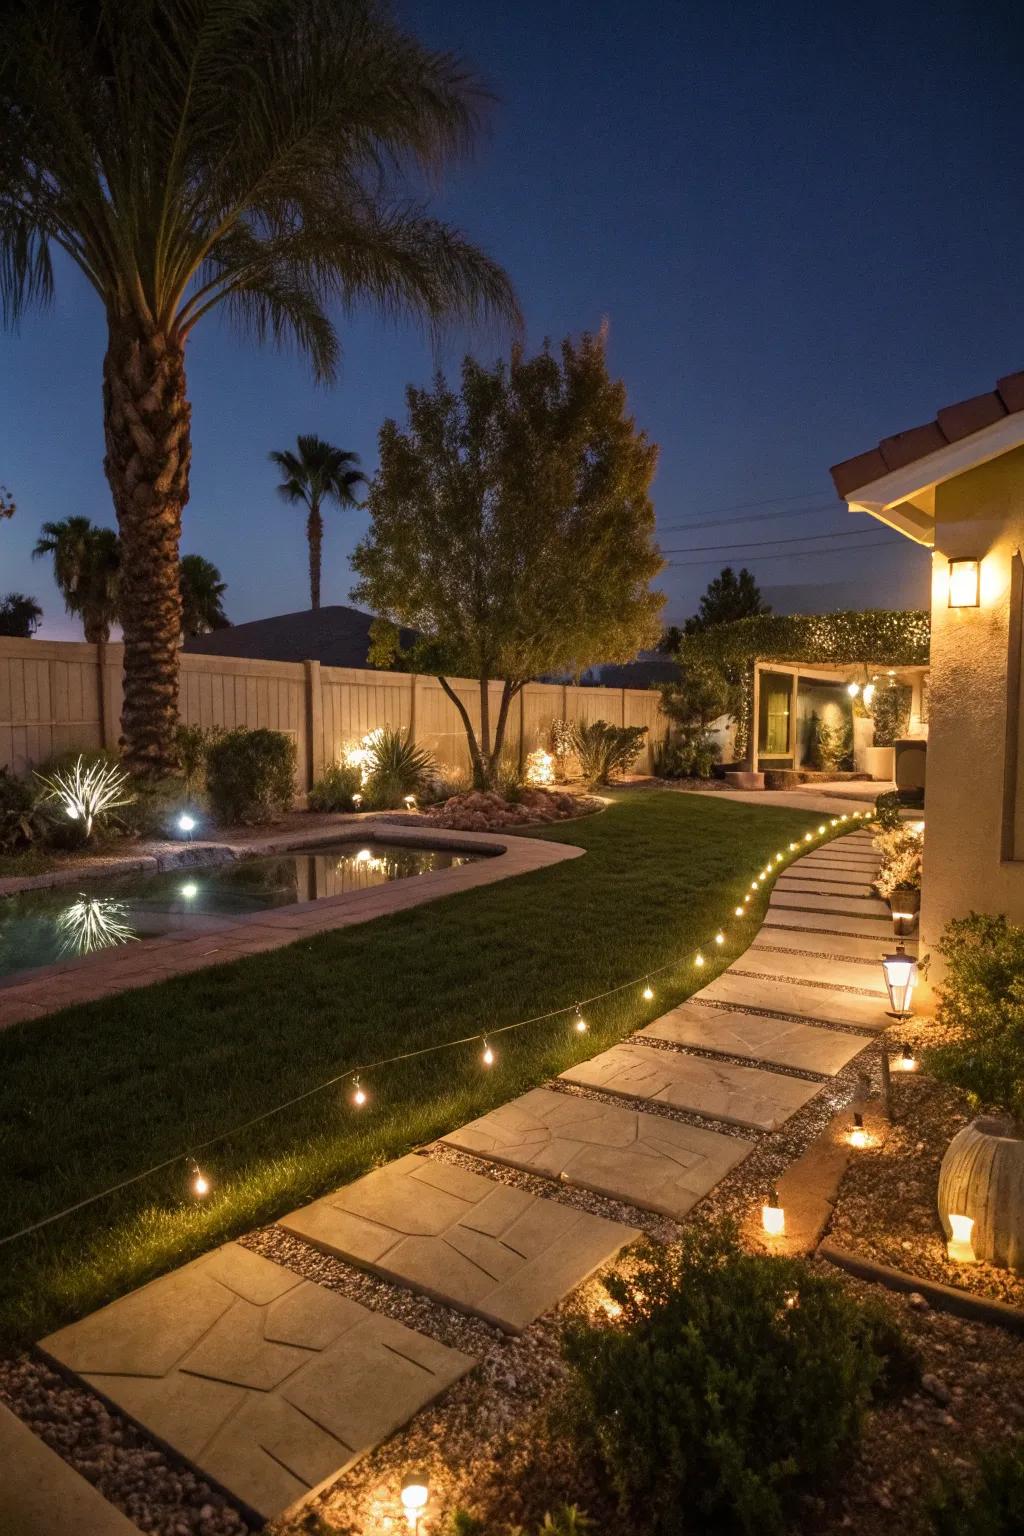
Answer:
[{"xmin": 0, "ymin": 0, "xmax": 516, "ymax": 776}]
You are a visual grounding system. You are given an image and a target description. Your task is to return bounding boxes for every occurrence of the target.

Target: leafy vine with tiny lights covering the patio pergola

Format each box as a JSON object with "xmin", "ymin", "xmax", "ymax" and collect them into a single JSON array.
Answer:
[{"xmin": 679, "ymin": 608, "xmax": 932, "ymax": 760}]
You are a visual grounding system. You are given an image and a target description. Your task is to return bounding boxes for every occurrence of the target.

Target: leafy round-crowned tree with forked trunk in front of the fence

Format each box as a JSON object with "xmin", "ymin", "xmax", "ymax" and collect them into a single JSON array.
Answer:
[{"xmin": 352, "ymin": 335, "xmax": 665, "ymax": 785}]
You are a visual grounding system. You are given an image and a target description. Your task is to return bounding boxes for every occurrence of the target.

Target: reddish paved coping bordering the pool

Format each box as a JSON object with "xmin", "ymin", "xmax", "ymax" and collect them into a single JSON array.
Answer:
[{"xmin": 0, "ymin": 817, "xmax": 585, "ymax": 1029}]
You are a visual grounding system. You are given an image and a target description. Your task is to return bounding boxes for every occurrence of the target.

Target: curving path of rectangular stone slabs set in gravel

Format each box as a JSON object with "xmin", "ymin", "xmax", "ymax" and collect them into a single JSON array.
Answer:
[{"xmin": 33, "ymin": 829, "xmax": 892, "ymax": 1536}]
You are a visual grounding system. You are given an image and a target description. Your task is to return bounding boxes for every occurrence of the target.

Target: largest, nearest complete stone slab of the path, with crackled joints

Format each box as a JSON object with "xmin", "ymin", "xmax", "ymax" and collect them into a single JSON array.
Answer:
[{"xmin": 40, "ymin": 1243, "xmax": 474, "ymax": 1521}]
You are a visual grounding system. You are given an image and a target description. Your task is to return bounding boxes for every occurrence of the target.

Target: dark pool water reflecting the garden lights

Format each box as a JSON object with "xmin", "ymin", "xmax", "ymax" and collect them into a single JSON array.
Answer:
[{"xmin": 0, "ymin": 839, "xmax": 488, "ymax": 983}]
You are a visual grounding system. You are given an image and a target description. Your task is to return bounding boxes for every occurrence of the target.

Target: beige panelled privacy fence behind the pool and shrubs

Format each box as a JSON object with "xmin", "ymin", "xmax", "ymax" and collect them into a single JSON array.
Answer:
[{"xmin": 0, "ymin": 639, "xmax": 666, "ymax": 794}]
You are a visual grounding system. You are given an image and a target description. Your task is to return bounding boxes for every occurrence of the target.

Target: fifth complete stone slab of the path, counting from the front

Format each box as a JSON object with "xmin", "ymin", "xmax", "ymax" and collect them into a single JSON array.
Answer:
[{"xmin": 639, "ymin": 1003, "xmax": 869, "ymax": 1077}]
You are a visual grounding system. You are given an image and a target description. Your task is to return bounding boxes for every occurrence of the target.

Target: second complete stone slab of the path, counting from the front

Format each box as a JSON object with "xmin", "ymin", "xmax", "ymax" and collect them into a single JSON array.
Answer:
[{"xmin": 278, "ymin": 1152, "xmax": 639, "ymax": 1332}]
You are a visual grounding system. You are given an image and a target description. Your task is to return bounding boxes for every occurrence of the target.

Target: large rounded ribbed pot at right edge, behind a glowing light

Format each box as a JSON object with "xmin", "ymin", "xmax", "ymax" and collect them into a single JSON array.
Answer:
[{"xmin": 938, "ymin": 1117, "xmax": 1024, "ymax": 1270}]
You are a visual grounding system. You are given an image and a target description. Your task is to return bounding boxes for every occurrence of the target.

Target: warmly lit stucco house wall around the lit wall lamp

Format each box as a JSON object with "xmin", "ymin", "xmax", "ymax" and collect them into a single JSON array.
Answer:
[{"xmin": 921, "ymin": 449, "xmax": 1024, "ymax": 952}]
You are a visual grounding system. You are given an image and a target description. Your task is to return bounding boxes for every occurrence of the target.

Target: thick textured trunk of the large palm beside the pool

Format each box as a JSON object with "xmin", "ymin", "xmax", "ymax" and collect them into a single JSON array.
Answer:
[{"xmin": 103, "ymin": 313, "xmax": 192, "ymax": 779}]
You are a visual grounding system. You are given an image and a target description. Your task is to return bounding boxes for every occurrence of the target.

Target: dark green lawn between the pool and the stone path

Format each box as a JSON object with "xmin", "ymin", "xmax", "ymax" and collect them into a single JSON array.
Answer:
[{"xmin": 0, "ymin": 791, "xmax": 841, "ymax": 1344}]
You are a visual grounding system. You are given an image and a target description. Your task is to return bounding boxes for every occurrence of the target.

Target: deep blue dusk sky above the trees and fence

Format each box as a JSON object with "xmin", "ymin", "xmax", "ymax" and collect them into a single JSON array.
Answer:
[{"xmin": 0, "ymin": 0, "xmax": 1024, "ymax": 634}]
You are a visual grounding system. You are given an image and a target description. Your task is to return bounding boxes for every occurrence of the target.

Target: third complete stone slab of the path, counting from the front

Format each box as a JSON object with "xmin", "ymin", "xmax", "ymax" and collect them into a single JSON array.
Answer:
[{"xmin": 444, "ymin": 1087, "xmax": 751, "ymax": 1218}]
